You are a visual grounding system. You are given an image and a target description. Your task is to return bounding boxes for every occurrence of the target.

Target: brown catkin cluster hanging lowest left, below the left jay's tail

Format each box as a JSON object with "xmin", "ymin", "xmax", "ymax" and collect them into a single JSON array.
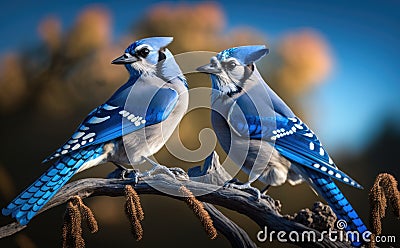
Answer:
[{"xmin": 62, "ymin": 196, "xmax": 98, "ymax": 248}]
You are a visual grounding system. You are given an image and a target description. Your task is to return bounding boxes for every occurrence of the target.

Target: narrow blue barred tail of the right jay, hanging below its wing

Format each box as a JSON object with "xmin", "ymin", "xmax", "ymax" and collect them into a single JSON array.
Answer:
[{"xmin": 306, "ymin": 169, "xmax": 367, "ymax": 247}]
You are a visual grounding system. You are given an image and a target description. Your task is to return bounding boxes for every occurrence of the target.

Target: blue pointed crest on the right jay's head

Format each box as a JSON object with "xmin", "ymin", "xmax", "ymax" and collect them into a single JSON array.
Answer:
[{"xmin": 217, "ymin": 46, "xmax": 269, "ymax": 65}]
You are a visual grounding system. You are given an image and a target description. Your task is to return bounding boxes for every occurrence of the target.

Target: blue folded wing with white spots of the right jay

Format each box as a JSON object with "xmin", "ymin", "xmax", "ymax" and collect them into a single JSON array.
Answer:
[{"xmin": 228, "ymin": 98, "xmax": 362, "ymax": 188}]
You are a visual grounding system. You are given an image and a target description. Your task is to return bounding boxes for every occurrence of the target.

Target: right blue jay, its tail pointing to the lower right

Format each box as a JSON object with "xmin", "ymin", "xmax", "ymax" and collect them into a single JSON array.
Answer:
[{"xmin": 197, "ymin": 46, "xmax": 367, "ymax": 245}]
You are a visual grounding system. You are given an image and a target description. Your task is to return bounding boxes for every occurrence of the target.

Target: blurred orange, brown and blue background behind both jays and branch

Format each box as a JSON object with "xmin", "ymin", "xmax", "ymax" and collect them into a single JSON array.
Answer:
[{"xmin": 0, "ymin": 0, "xmax": 400, "ymax": 247}]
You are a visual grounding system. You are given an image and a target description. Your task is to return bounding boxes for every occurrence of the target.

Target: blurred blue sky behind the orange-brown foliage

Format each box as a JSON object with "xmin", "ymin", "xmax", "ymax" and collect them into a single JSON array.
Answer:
[{"xmin": 0, "ymin": 0, "xmax": 400, "ymax": 151}]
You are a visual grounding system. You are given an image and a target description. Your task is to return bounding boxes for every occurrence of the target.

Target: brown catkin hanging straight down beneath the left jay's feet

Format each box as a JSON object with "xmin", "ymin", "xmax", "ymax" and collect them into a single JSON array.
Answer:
[{"xmin": 125, "ymin": 185, "xmax": 144, "ymax": 241}]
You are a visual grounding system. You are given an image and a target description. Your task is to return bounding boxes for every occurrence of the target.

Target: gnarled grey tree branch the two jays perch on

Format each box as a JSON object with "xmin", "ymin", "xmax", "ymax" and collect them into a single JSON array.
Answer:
[{"xmin": 0, "ymin": 153, "xmax": 351, "ymax": 247}]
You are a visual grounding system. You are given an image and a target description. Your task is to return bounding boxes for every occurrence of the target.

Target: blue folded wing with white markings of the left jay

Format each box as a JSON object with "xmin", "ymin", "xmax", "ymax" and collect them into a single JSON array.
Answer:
[{"xmin": 43, "ymin": 88, "xmax": 178, "ymax": 163}]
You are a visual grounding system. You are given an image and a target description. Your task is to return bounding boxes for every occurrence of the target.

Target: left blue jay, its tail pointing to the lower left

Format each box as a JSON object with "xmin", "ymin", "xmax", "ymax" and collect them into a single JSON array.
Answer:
[{"xmin": 2, "ymin": 37, "xmax": 188, "ymax": 225}]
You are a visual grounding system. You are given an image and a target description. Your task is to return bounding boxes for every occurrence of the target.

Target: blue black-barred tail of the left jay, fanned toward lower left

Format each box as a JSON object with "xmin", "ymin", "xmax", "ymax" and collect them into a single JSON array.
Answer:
[{"xmin": 2, "ymin": 145, "xmax": 103, "ymax": 225}]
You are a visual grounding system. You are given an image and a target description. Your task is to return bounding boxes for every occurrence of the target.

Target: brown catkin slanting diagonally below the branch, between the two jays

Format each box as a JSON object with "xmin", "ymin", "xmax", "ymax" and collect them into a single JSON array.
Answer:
[{"xmin": 180, "ymin": 186, "xmax": 217, "ymax": 239}]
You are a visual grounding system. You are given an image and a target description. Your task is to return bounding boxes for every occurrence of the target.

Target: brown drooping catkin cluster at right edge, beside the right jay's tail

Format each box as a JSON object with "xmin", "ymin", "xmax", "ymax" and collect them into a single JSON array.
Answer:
[{"xmin": 369, "ymin": 173, "xmax": 400, "ymax": 247}]
